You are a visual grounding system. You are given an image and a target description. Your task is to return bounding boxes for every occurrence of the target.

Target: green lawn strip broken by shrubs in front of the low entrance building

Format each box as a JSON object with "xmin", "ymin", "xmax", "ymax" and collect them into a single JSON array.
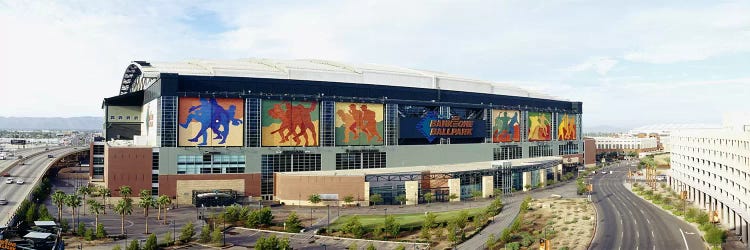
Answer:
[{"xmin": 331, "ymin": 207, "xmax": 486, "ymax": 230}]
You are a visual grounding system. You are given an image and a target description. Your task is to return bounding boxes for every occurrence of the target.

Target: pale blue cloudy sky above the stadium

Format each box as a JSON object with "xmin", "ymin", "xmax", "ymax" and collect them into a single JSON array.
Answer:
[{"xmin": 0, "ymin": 0, "xmax": 750, "ymax": 128}]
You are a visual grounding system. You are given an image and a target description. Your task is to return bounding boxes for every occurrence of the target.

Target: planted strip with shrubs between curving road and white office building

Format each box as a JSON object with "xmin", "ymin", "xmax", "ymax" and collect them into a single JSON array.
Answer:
[{"xmin": 630, "ymin": 183, "xmax": 727, "ymax": 250}]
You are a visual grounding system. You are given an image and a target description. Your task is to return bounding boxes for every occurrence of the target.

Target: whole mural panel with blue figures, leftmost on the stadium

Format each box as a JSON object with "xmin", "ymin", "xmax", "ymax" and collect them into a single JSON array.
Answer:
[{"xmin": 177, "ymin": 97, "xmax": 245, "ymax": 146}]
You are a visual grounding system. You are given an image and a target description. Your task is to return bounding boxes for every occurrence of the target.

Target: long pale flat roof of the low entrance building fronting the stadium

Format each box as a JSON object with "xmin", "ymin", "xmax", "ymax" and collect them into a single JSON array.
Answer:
[{"xmin": 277, "ymin": 156, "xmax": 562, "ymax": 176}]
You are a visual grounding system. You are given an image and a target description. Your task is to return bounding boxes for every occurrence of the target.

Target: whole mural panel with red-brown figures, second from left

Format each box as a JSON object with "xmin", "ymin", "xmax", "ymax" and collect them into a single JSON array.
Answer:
[{"xmin": 261, "ymin": 100, "xmax": 320, "ymax": 147}]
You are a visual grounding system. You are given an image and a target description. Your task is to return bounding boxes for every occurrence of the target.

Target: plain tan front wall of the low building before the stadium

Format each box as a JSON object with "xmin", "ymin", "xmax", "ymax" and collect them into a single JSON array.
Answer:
[{"xmin": 274, "ymin": 174, "xmax": 369, "ymax": 206}]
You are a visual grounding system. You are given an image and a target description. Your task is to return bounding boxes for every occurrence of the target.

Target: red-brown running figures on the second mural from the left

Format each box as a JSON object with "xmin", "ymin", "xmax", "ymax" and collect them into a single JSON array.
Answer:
[{"xmin": 268, "ymin": 101, "xmax": 318, "ymax": 146}]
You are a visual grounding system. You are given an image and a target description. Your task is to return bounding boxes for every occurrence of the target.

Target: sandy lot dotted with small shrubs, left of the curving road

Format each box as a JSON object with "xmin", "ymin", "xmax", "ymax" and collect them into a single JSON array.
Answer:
[{"xmin": 520, "ymin": 198, "xmax": 596, "ymax": 249}]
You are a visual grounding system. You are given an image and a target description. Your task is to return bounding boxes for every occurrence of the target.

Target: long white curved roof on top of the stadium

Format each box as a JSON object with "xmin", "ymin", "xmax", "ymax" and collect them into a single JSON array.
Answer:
[{"xmin": 120, "ymin": 59, "xmax": 569, "ymax": 101}]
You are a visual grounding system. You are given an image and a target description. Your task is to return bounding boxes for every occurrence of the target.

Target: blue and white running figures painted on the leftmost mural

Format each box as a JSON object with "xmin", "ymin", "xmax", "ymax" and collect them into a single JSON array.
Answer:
[{"xmin": 180, "ymin": 98, "xmax": 242, "ymax": 146}]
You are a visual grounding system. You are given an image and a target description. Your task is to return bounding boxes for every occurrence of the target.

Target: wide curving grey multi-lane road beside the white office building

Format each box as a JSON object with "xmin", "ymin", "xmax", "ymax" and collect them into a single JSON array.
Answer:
[{"xmin": 589, "ymin": 162, "xmax": 705, "ymax": 250}]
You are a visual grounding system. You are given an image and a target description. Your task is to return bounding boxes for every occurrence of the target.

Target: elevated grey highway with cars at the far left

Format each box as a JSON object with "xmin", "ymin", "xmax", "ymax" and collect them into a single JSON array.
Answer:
[{"xmin": 0, "ymin": 147, "xmax": 80, "ymax": 226}]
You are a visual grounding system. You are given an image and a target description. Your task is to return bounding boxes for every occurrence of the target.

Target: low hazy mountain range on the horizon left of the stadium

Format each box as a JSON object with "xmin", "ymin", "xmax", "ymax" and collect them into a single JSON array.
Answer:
[{"xmin": 0, "ymin": 116, "xmax": 104, "ymax": 130}]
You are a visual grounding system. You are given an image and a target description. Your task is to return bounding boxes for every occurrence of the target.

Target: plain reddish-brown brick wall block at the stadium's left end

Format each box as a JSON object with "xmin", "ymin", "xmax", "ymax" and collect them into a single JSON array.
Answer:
[{"xmin": 104, "ymin": 146, "xmax": 152, "ymax": 196}]
